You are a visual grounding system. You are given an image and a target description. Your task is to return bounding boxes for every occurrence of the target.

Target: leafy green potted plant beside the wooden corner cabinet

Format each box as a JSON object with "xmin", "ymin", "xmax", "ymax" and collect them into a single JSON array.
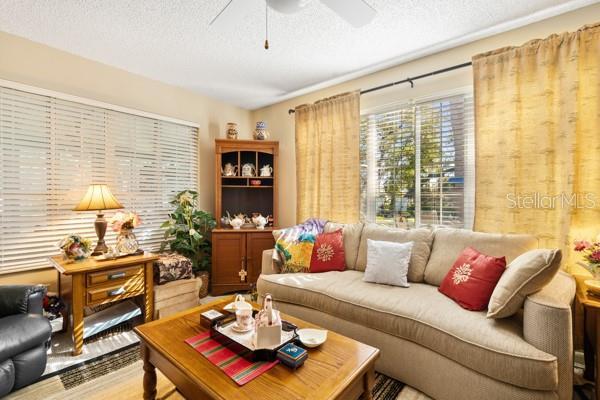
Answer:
[{"xmin": 160, "ymin": 190, "xmax": 216, "ymax": 297}]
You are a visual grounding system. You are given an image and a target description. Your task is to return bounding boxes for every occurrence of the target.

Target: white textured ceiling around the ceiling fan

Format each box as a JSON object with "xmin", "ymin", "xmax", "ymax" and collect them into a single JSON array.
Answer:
[{"xmin": 0, "ymin": 0, "xmax": 596, "ymax": 109}]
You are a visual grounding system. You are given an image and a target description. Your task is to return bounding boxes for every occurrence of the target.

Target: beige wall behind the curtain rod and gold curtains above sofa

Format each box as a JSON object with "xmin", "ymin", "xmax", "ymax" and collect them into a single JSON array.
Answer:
[{"xmin": 252, "ymin": 4, "xmax": 600, "ymax": 226}]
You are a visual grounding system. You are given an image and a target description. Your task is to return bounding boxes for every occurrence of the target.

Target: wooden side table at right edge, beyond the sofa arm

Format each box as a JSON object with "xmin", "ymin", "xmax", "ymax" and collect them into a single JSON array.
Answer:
[{"xmin": 574, "ymin": 274, "xmax": 600, "ymax": 400}]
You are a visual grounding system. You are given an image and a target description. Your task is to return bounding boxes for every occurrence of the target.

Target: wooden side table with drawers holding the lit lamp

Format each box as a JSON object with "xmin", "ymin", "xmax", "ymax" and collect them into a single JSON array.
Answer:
[{"xmin": 50, "ymin": 254, "xmax": 159, "ymax": 355}]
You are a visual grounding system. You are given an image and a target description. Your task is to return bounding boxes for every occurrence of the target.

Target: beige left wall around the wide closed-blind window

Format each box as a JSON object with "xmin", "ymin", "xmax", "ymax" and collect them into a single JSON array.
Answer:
[{"xmin": 0, "ymin": 32, "xmax": 252, "ymax": 288}]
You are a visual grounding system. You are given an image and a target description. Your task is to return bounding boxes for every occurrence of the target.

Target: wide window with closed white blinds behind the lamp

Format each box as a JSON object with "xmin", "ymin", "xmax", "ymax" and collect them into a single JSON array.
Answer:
[{"xmin": 0, "ymin": 86, "xmax": 198, "ymax": 273}]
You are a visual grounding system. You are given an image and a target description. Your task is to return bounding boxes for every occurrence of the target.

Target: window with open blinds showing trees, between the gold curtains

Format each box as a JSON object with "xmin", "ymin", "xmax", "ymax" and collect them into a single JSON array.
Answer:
[{"xmin": 360, "ymin": 93, "xmax": 474, "ymax": 228}]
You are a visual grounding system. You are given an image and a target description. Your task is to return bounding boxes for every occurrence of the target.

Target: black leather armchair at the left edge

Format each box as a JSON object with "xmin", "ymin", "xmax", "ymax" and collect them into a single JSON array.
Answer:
[{"xmin": 0, "ymin": 285, "xmax": 52, "ymax": 398}]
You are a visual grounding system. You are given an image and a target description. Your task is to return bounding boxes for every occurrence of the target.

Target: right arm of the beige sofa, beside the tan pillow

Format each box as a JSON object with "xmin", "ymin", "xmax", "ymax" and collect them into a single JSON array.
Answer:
[{"xmin": 523, "ymin": 271, "xmax": 576, "ymax": 399}]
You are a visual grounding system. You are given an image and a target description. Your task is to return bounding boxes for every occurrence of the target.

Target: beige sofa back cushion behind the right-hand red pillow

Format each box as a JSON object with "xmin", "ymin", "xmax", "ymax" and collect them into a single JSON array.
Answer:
[{"xmin": 425, "ymin": 228, "xmax": 538, "ymax": 286}]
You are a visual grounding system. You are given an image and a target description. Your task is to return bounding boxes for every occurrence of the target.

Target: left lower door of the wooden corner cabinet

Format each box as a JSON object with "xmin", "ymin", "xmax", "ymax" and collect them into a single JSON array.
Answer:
[{"xmin": 211, "ymin": 232, "xmax": 246, "ymax": 292}]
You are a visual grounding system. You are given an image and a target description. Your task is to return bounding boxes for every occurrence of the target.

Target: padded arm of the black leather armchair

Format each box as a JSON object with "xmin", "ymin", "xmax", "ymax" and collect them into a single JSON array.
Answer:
[{"xmin": 0, "ymin": 285, "xmax": 46, "ymax": 317}]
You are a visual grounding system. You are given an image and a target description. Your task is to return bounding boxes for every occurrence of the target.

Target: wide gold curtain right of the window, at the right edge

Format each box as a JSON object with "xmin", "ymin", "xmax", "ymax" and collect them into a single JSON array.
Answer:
[{"xmin": 473, "ymin": 24, "xmax": 600, "ymax": 264}]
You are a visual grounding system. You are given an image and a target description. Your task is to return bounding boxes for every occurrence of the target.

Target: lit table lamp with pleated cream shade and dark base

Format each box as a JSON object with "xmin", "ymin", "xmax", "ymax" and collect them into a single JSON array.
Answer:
[{"xmin": 73, "ymin": 184, "xmax": 123, "ymax": 256}]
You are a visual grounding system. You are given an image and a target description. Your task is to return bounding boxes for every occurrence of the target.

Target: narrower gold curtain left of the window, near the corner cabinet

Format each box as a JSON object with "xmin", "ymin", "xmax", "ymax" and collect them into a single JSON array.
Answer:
[{"xmin": 295, "ymin": 91, "xmax": 360, "ymax": 222}]
